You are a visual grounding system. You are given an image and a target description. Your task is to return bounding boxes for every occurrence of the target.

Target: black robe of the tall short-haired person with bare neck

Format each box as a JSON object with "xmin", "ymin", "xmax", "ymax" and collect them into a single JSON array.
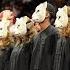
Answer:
[{"xmin": 30, "ymin": 25, "xmax": 58, "ymax": 70}]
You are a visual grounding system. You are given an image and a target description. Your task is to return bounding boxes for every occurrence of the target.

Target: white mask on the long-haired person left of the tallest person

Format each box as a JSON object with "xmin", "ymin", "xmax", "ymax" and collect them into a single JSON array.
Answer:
[{"xmin": 10, "ymin": 16, "xmax": 29, "ymax": 36}]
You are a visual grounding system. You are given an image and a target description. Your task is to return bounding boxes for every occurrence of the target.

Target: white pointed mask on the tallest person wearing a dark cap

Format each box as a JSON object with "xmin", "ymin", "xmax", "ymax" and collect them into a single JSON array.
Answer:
[{"xmin": 32, "ymin": 1, "xmax": 47, "ymax": 23}]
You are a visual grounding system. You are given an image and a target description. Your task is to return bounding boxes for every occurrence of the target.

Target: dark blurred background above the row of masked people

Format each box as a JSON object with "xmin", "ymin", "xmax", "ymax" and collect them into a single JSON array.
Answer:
[{"xmin": 0, "ymin": 0, "xmax": 70, "ymax": 17}]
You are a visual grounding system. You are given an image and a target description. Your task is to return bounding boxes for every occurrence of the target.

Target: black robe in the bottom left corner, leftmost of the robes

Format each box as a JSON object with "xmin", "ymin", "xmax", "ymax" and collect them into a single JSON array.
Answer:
[{"xmin": 0, "ymin": 45, "xmax": 13, "ymax": 70}]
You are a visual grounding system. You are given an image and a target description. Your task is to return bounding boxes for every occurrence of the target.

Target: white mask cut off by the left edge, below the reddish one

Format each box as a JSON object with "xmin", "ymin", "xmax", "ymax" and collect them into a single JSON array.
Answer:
[{"xmin": 0, "ymin": 22, "xmax": 8, "ymax": 38}]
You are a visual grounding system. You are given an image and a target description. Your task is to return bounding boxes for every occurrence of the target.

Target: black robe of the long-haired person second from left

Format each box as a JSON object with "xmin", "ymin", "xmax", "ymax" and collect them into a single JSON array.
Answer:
[{"xmin": 9, "ymin": 43, "xmax": 31, "ymax": 70}]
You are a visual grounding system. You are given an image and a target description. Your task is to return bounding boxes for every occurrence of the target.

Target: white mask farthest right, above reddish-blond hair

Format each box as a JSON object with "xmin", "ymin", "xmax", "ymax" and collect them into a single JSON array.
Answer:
[{"xmin": 54, "ymin": 6, "xmax": 68, "ymax": 28}]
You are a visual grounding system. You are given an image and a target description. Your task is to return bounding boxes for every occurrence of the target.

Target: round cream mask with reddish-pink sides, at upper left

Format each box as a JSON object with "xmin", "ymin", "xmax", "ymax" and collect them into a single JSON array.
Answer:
[{"xmin": 0, "ymin": 10, "xmax": 15, "ymax": 26}]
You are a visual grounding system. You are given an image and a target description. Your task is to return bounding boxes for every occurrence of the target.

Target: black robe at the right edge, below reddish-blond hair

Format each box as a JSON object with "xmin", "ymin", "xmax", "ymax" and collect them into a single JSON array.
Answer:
[{"xmin": 53, "ymin": 37, "xmax": 70, "ymax": 70}]
